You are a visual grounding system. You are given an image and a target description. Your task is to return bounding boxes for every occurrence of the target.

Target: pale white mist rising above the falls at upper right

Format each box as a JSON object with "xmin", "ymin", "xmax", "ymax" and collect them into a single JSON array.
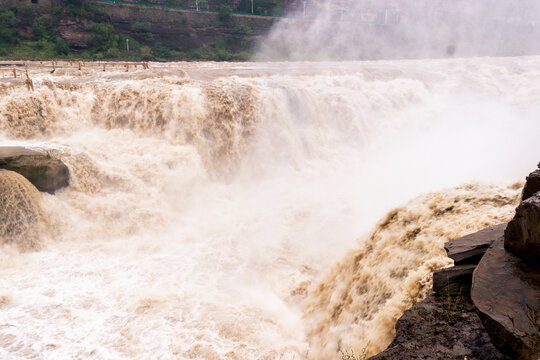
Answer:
[{"xmin": 256, "ymin": 0, "xmax": 540, "ymax": 60}]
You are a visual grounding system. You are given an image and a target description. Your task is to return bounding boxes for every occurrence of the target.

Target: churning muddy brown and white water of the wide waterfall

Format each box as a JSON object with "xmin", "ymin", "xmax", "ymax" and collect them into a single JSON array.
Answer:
[{"xmin": 0, "ymin": 57, "xmax": 540, "ymax": 359}]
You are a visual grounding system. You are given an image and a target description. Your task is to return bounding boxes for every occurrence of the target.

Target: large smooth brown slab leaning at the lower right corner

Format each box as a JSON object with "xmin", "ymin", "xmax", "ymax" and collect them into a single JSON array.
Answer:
[{"xmin": 471, "ymin": 236, "xmax": 540, "ymax": 360}]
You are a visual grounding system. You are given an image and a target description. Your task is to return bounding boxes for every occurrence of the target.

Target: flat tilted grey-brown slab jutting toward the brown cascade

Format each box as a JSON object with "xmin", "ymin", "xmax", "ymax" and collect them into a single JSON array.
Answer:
[{"xmin": 444, "ymin": 223, "xmax": 507, "ymax": 265}]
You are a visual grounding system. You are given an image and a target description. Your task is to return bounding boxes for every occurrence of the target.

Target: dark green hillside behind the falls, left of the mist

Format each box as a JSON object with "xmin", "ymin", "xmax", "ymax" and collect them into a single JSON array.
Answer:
[{"xmin": 0, "ymin": 0, "xmax": 274, "ymax": 61}]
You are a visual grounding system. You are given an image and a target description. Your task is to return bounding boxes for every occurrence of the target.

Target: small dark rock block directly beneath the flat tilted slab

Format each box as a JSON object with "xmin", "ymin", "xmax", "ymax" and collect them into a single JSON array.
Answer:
[{"xmin": 433, "ymin": 265, "xmax": 476, "ymax": 297}]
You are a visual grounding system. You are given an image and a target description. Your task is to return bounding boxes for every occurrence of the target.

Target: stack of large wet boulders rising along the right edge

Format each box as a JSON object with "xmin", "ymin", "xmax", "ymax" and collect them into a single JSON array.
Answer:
[{"xmin": 471, "ymin": 165, "xmax": 540, "ymax": 360}]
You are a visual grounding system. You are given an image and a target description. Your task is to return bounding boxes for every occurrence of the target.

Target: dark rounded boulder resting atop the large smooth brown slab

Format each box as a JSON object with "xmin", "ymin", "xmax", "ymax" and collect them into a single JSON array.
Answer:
[{"xmin": 504, "ymin": 193, "xmax": 540, "ymax": 271}]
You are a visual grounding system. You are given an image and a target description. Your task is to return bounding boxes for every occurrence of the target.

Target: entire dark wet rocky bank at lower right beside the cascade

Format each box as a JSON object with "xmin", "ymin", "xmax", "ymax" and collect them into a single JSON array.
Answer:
[{"xmin": 370, "ymin": 164, "xmax": 540, "ymax": 360}]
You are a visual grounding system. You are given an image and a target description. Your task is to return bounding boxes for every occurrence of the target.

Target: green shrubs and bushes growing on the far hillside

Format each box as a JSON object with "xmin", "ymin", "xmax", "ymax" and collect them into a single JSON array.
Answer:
[{"xmin": 0, "ymin": 0, "xmax": 258, "ymax": 61}]
